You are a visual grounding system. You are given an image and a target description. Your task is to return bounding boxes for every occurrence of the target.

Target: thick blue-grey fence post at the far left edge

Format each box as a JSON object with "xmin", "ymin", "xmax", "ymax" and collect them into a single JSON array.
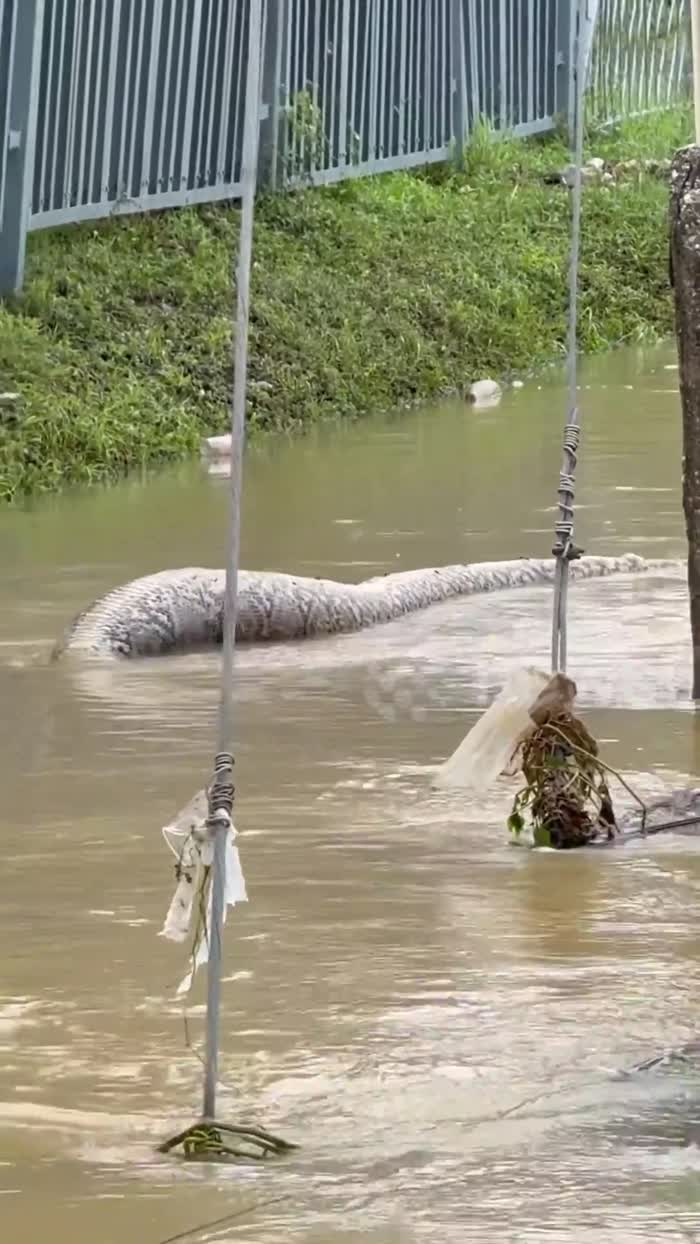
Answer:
[{"xmin": 0, "ymin": 0, "xmax": 44, "ymax": 295}]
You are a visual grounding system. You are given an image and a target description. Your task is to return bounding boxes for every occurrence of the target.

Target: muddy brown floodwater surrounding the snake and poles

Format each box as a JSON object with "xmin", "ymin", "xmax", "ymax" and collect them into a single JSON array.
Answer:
[{"xmin": 0, "ymin": 346, "xmax": 700, "ymax": 1244}]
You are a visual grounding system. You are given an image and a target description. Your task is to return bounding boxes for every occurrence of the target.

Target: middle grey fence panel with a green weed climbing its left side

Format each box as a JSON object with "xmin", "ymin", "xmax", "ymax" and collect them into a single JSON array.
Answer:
[{"xmin": 282, "ymin": 0, "xmax": 453, "ymax": 184}]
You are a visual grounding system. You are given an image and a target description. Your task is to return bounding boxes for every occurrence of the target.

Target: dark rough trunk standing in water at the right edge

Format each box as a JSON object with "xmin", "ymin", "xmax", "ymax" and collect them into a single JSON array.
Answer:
[{"xmin": 670, "ymin": 147, "xmax": 700, "ymax": 699}]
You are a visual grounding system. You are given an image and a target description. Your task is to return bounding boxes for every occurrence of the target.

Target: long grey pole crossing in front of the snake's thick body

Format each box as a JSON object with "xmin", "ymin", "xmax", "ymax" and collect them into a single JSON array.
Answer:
[{"xmin": 203, "ymin": 0, "xmax": 262, "ymax": 1120}]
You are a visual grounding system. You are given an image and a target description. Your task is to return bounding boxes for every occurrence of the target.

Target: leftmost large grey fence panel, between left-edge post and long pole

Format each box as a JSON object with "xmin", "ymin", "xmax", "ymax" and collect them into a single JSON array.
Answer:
[{"xmin": 30, "ymin": 0, "xmax": 247, "ymax": 229}]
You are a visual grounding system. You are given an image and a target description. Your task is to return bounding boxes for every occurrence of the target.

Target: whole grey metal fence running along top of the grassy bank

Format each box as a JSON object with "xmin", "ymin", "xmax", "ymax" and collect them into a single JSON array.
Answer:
[{"xmin": 0, "ymin": 0, "xmax": 688, "ymax": 292}]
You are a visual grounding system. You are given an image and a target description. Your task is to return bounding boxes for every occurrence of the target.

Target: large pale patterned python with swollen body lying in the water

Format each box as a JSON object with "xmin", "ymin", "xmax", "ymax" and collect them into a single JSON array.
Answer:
[{"xmin": 53, "ymin": 554, "xmax": 678, "ymax": 658}]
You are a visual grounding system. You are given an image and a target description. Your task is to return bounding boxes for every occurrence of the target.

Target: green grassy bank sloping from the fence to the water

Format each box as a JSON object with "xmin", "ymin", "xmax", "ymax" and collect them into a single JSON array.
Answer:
[{"xmin": 0, "ymin": 106, "xmax": 690, "ymax": 501}]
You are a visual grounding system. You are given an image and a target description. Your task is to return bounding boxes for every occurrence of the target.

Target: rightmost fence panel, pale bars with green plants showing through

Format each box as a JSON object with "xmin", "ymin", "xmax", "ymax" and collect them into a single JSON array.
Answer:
[{"xmin": 588, "ymin": 0, "xmax": 691, "ymax": 121}]
